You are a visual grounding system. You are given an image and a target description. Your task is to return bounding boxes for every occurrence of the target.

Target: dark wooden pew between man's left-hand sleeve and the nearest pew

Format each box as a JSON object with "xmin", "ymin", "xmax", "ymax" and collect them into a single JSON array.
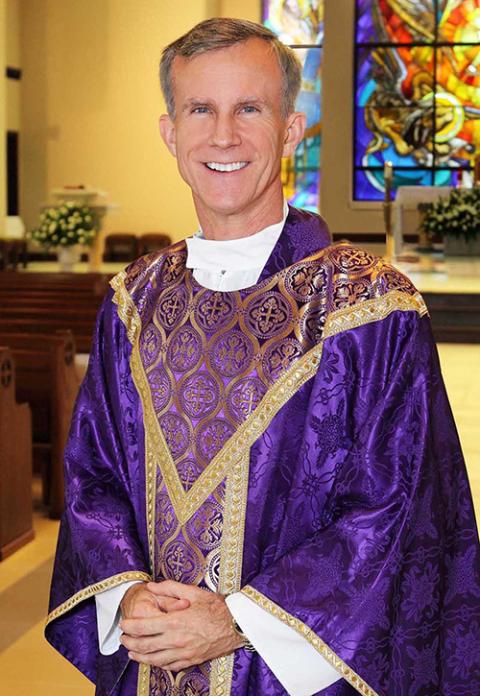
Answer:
[{"xmin": 0, "ymin": 324, "xmax": 80, "ymax": 518}]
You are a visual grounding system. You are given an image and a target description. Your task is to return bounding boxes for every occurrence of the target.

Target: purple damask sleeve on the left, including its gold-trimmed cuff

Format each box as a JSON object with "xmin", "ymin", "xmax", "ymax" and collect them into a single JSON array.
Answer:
[{"xmin": 46, "ymin": 293, "xmax": 150, "ymax": 693}]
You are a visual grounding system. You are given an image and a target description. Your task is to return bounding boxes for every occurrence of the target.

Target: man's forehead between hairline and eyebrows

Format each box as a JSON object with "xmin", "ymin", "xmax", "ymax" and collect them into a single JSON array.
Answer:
[{"xmin": 172, "ymin": 38, "xmax": 283, "ymax": 101}]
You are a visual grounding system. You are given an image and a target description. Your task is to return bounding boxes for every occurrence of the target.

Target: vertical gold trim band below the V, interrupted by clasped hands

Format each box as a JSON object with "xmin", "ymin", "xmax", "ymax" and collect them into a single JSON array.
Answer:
[{"xmin": 210, "ymin": 449, "xmax": 250, "ymax": 696}]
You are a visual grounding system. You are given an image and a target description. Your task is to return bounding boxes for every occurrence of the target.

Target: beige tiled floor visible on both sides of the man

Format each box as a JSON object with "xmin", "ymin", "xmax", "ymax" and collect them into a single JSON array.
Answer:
[{"xmin": 0, "ymin": 345, "xmax": 480, "ymax": 696}]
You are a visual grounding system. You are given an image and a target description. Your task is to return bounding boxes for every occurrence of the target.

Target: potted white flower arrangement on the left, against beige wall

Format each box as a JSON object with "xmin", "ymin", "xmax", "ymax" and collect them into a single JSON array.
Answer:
[{"xmin": 29, "ymin": 201, "xmax": 97, "ymax": 271}]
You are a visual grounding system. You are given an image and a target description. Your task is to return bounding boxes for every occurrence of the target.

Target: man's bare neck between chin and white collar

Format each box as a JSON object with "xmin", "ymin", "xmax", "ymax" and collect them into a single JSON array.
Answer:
[{"xmin": 194, "ymin": 187, "xmax": 283, "ymax": 241}]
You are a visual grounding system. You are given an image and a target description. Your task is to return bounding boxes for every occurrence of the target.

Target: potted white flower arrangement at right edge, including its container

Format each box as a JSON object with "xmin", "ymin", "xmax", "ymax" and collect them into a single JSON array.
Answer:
[{"xmin": 419, "ymin": 187, "xmax": 480, "ymax": 256}]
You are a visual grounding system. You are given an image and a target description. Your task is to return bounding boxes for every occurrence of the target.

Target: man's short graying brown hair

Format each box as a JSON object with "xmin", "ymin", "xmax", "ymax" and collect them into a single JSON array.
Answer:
[{"xmin": 160, "ymin": 17, "xmax": 302, "ymax": 118}]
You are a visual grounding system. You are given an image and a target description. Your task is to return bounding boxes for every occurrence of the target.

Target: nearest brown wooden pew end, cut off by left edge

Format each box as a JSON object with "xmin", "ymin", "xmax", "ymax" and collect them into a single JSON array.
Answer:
[{"xmin": 0, "ymin": 346, "xmax": 34, "ymax": 560}]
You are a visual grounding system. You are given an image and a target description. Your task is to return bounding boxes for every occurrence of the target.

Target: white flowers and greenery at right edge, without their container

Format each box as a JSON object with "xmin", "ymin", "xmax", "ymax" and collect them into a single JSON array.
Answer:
[{"xmin": 418, "ymin": 188, "xmax": 480, "ymax": 240}]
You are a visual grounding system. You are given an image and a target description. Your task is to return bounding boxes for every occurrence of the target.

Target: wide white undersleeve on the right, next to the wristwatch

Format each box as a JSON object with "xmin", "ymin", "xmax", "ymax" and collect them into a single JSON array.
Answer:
[{"xmin": 226, "ymin": 592, "xmax": 341, "ymax": 696}]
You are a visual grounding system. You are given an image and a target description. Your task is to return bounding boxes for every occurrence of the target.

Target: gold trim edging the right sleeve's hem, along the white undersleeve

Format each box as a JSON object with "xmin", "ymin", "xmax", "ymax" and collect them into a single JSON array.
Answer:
[{"xmin": 242, "ymin": 585, "xmax": 378, "ymax": 696}]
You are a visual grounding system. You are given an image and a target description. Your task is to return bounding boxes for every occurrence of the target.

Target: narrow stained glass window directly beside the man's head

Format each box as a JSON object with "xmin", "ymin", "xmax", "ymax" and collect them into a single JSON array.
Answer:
[{"xmin": 263, "ymin": 0, "xmax": 323, "ymax": 210}]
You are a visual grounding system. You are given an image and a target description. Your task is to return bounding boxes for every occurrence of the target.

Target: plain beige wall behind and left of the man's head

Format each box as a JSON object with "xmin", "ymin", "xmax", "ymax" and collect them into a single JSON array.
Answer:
[{"xmin": 21, "ymin": 0, "xmax": 219, "ymax": 238}]
